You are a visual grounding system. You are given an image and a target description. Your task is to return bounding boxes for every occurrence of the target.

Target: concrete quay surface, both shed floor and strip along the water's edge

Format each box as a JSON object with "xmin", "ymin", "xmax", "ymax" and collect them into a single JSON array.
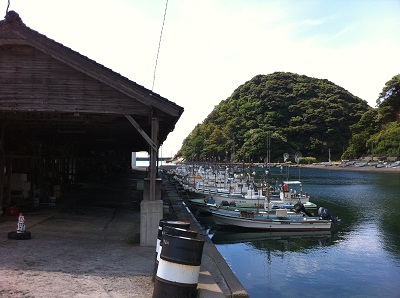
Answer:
[{"xmin": 0, "ymin": 172, "xmax": 248, "ymax": 298}]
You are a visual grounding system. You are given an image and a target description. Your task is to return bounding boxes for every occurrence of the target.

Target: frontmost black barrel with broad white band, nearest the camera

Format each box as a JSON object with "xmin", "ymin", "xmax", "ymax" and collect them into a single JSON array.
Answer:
[{"xmin": 153, "ymin": 234, "xmax": 205, "ymax": 298}]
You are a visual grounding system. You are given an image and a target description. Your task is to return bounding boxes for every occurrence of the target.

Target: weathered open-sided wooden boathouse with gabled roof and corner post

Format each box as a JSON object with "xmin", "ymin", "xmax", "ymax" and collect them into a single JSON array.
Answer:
[{"xmin": 0, "ymin": 11, "xmax": 183, "ymax": 246}]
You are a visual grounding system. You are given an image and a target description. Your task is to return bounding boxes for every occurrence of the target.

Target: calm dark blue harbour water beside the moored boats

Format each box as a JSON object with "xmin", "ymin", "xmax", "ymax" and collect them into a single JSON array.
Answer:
[{"xmin": 199, "ymin": 169, "xmax": 400, "ymax": 297}]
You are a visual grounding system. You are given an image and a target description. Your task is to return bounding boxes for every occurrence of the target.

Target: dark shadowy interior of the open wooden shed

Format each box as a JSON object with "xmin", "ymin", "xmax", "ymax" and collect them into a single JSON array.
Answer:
[{"xmin": 0, "ymin": 115, "xmax": 140, "ymax": 213}]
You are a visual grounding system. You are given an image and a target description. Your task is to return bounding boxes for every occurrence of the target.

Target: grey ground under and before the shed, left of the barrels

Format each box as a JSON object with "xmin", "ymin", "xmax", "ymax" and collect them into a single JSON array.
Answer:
[{"xmin": 0, "ymin": 176, "xmax": 155, "ymax": 298}]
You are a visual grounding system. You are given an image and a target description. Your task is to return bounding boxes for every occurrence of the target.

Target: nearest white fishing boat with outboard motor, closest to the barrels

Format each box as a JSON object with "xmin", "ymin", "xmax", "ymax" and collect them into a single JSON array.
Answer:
[{"xmin": 211, "ymin": 207, "xmax": 339, "ymax": 232}]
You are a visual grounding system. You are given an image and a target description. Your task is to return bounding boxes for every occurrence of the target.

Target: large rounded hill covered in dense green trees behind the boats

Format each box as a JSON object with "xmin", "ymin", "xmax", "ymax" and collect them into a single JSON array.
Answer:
[{"xmin": 178, "ymin": 72, "xmax": 370, "ymax": 162}]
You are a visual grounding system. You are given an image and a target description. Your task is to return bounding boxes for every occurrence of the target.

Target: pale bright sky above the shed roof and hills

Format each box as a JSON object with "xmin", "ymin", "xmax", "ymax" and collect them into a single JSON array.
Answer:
[{"xmin": 5, "ymin": 0, "xmax": 400, "ymax": 157}]
